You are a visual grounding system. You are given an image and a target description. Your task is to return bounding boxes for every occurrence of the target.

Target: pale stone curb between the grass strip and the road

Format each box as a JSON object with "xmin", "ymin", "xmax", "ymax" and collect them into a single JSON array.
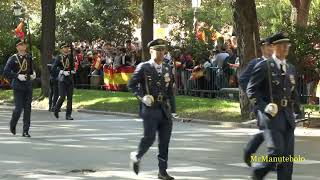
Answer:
[{"xmin": 0, "ymin": 103, "xmax": 257, "ymax": 128}]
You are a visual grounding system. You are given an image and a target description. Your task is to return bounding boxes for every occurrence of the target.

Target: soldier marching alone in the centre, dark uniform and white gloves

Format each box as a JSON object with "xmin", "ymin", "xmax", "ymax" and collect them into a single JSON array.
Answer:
[{"xmin": 128, "ymin": 39, "xmax": 174, "ymax": 180}]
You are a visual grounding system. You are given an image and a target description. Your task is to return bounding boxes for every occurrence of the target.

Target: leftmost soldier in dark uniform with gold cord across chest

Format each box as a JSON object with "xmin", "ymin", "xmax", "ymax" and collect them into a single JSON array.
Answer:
[{"xmin": 4, "ymin": 39, "xmax": 36, "ymax": 137}]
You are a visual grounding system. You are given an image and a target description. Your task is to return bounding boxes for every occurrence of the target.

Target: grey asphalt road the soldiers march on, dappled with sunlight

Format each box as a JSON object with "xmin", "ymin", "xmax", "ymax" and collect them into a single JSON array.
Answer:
[{"xmin": 0, "ymin": 109, "xmax": 320, "ymax": 180}]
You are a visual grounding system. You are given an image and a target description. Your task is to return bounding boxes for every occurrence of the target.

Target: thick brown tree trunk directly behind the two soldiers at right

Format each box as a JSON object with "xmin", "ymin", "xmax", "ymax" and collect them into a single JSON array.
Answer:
[{"xmin": 233, "ymin": 0, "xmax": 260, "ymax": 119}]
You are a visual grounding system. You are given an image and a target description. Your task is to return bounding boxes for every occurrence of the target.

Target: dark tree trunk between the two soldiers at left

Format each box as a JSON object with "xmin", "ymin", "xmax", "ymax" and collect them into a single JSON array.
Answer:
[{"xmin": 40, "ymin": 0, "xmax": 56, "ymax": 97}]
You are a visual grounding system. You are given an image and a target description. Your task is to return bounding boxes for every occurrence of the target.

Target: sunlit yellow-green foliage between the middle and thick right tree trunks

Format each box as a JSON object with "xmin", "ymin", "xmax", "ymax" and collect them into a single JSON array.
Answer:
[{"xmin": 155, "ymin": 0, "xmax": 233, "ymax": 35}]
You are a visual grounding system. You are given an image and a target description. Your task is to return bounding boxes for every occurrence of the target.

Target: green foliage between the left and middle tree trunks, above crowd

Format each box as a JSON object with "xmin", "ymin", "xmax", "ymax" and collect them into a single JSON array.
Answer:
[{"xmin": 56, "ymin": 0, "xmax": 136, "ymax": 42}]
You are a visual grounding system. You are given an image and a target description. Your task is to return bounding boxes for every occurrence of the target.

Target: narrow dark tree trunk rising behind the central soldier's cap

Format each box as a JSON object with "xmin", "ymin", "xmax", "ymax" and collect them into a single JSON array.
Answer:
[{"xmin": 141, "ymin": 0, "xmax": 154, "ymax": 61}]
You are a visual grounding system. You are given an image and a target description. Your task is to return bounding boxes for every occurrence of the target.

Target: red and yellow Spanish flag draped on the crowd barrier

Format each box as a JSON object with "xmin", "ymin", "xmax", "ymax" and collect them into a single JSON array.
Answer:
[{"xmin": 104, "ymin": 66, "xmax": 135, "ymax": 91}]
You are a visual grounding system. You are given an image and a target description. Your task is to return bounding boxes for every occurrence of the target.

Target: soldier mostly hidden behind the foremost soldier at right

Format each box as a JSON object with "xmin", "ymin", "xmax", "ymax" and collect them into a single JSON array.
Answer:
[{"xmin": 239, "ymin": 38, "xmax": 273, "ymax": 166}]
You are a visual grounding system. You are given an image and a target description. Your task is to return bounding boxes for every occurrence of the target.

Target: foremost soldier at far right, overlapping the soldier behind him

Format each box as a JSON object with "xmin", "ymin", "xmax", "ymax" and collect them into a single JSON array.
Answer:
[{"xmin": 247, "ymin": 33, "xmax": 302, "ymax": 180}]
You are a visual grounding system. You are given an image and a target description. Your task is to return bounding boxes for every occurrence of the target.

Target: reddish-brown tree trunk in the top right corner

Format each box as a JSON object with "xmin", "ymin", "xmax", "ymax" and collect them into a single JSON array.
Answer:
[{"xmin": 290, "ymin": 0, "xmax": 311, "ymax": 27}]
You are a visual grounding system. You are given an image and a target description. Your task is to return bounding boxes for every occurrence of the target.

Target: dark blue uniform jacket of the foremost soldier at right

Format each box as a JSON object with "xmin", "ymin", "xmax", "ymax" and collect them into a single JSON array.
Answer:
[{"xmin": 247, "ymin": 59, "xmax": 301, "ymax": 130}]
